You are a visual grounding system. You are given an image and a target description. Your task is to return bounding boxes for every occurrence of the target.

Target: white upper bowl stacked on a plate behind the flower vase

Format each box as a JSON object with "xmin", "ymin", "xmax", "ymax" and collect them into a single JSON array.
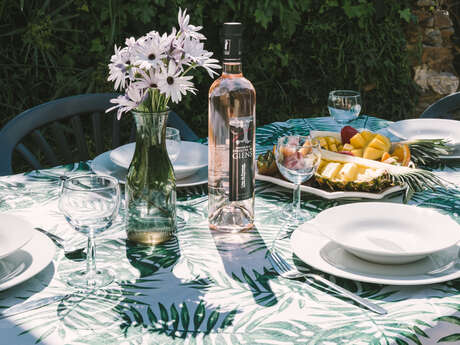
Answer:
[{"xmin": 110, "ymin": 141, "xmax": 208, "ymax": 180}]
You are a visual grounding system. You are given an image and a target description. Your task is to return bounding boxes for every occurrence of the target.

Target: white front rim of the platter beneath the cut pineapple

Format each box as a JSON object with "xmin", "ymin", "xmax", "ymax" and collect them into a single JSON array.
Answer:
[{"xmin": 256, "ymin": 173, "xmax": 405, "ymax": 200}]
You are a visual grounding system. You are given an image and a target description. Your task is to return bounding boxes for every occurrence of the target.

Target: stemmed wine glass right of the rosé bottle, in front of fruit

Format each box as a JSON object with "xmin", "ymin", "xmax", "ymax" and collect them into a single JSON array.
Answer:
[{"xmin": 275, "ymin": 135, "xmax": 321, "ymax": 220}]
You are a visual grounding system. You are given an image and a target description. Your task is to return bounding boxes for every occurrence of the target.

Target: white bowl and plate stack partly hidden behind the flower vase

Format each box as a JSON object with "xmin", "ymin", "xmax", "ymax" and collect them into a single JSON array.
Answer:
[{"xmin": 91, "ymin": 141, "xmax": 208, "ymax": 187}]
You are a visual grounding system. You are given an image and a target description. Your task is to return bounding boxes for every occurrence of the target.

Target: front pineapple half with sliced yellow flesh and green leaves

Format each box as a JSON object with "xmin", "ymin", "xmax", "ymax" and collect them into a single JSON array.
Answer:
[{"xmin": 315, "ymin": 149, "xmax": 449, "ymax": 202}]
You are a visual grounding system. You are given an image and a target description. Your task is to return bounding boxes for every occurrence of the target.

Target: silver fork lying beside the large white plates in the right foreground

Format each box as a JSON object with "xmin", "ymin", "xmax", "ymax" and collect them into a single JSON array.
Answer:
[{"xmin": 268, "ymin": 251, "xmax": 388, "ymax": 315}]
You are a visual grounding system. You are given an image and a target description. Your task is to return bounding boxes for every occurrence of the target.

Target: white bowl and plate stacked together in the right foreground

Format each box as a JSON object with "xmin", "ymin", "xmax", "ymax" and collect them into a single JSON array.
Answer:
[{"xmin": 291, "ymin": 202, "xmax": 460, "ymax": 285}]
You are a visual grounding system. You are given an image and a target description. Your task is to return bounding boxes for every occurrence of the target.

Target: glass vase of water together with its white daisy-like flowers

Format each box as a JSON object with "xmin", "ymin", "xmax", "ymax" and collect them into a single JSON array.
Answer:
[{"xmin": 107, "ymin": 9, "xmax": 220, "ymax": 244}]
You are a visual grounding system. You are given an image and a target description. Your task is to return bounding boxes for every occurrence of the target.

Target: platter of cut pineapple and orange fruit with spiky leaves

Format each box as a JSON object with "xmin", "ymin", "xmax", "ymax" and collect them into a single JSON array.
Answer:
[{"xmin": 256, "ymin": 126, "xmax": 448, "ymax": 202}]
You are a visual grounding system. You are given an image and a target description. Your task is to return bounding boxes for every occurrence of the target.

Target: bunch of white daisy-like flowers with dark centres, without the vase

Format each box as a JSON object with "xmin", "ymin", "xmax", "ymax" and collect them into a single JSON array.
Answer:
[{"xmin": 106, "ymin": 9, "xmax": 220, "ymax": 118}]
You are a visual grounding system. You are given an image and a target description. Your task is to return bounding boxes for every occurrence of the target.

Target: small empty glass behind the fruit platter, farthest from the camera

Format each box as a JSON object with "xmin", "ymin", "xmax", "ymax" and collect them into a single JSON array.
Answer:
[{"xmin": 327, "ymin": 90, "xmax": 361, "ymax": 124}]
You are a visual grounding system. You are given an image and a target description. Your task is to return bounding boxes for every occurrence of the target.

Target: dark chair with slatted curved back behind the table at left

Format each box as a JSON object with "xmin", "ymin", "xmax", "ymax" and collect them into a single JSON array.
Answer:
[{"xmin": 0, "ymin": 93, "xmax": 198, "ymax": 176}]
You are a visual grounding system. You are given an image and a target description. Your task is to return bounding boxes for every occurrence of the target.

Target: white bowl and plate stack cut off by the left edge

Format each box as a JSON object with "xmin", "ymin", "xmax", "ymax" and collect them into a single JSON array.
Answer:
[{"xmin": 0, "ymin": 214, "xmax": 55, "ymax": 291}]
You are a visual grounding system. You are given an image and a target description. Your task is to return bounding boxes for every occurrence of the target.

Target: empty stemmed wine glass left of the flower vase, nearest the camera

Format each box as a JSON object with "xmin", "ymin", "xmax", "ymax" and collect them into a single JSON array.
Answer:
[{"xmin": 59, "ymin": 174, "xmax": 120, "ymax": 288}]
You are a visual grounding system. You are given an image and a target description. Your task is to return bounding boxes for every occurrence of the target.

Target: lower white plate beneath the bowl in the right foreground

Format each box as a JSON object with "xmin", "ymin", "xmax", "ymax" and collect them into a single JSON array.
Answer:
[{"xmin": 291, "ymin": 223, "xmax": 460, "ymax": 285}]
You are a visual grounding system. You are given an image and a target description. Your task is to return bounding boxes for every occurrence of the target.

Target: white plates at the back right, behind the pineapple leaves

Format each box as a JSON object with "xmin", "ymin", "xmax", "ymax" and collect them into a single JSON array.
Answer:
[{"xmin": 386, "ymin": 119, "xmax": 460, "ymax": 159}]
